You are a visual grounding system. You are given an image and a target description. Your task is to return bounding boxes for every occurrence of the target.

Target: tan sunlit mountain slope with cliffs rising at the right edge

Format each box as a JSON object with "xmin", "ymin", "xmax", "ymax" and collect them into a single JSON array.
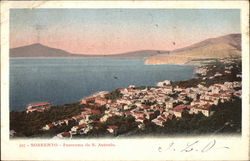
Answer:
[{"xmin": 145, "ymin": 34, "xmax": 241, "ymax": 64}]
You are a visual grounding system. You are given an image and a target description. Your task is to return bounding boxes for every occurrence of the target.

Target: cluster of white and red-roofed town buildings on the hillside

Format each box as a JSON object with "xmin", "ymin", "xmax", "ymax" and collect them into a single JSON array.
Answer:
[{"xmin": 43, "ymin": 58, "xmax": 242, "ymax": 138}]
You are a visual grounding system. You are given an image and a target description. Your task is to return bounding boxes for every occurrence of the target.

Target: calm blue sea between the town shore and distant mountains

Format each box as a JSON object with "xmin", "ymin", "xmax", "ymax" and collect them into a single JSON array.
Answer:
[{"xmin": 9, "ymin": 58, "xmax": 194, "ymax": 110}]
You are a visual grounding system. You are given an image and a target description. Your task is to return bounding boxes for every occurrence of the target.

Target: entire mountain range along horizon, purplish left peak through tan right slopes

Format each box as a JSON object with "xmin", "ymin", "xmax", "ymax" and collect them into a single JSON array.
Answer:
[{"xmin": 10, "ymin": 34, "xmax": 241, "ymax": 60}]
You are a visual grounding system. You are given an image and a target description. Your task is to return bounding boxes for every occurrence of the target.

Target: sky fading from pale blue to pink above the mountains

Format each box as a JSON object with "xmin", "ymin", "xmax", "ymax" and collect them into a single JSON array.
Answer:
[{"xmin": 10, "ymin": 9, "xmax": 240, "ymax": 54}]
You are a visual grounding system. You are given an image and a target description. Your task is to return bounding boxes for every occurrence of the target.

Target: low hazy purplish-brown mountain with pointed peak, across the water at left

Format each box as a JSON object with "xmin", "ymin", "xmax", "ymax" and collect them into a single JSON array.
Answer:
[{"xmin": 10, "ymin": 43, "xmax": 167, "ymax": 58}]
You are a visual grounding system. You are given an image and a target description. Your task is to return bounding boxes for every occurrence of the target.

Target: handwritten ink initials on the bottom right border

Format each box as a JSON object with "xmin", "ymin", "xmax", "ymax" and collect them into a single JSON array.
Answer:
[{"xmin": 158, "ymin": 139, "xmax": 230, "ymax": 153}]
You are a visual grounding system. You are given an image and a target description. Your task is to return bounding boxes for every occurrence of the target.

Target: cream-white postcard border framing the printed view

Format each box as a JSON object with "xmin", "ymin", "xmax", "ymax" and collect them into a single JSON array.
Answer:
[{"xmin": 1, "ymin": 1, "xmax": 250, "ymax": 160}]
